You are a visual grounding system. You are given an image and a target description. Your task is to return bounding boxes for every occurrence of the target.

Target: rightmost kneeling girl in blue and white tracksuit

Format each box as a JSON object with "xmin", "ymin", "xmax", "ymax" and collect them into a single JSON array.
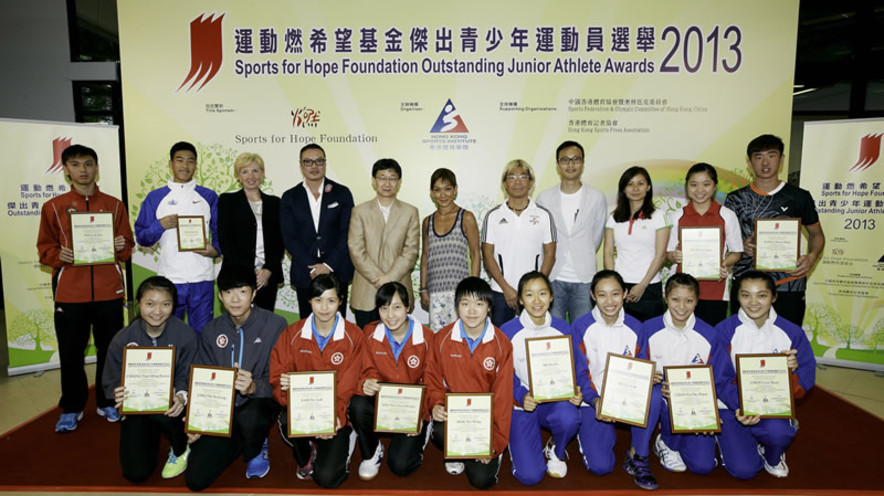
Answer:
[{"xmin": 715, "ymin": 271, "xmax": 816, "ymax": 479}]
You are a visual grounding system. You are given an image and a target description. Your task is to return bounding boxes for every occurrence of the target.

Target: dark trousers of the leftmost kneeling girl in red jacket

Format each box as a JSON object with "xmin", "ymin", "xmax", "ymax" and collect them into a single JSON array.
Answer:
[{"xmin": 279, "ymin": 410, "xmax": 356, "ymax": 488}]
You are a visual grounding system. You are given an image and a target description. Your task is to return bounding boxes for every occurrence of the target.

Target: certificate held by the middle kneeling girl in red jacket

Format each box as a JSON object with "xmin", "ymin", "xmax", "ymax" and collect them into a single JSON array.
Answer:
[{"xmin": 374, "ymin": 384, "xmax": 426, "ymax": 434}]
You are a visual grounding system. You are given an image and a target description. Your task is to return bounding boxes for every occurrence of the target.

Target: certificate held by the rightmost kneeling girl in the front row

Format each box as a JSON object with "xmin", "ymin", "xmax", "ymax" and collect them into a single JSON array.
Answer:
[{"xmin": 737, "ymin": 354, "xmax": 795, "ymax": 418}]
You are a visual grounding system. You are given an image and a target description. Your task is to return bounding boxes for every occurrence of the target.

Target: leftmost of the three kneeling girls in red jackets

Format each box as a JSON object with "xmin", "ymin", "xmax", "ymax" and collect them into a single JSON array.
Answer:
[{"xmin": 270, "ymin": 274, "xmax": 365, "ymax": 488}]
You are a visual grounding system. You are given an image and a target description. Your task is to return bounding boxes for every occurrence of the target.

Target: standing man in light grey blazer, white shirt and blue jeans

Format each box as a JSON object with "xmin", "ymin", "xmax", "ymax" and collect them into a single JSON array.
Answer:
[{"xmin": 537, "ymin": 141, "xmax": 608, "ymax": 322}]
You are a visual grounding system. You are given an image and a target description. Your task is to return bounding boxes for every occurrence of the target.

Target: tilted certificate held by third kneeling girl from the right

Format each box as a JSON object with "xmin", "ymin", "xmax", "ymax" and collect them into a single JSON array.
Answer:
[{"xmin": 599, "ymin": 353, "xmax": 655, "ymax": 427}]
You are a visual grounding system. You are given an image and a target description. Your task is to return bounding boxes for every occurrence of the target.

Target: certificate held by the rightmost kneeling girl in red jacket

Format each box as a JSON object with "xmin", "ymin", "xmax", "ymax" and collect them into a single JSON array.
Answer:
[{"xmin": 444, "ymin": 393, "xmax": 494, "ymax": 459}]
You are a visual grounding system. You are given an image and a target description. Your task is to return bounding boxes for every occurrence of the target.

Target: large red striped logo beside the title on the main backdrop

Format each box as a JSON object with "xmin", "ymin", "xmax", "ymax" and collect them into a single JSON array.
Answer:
[{"xmin": 178, "ymin": 14, "xmax": 225, "ymax": 91}]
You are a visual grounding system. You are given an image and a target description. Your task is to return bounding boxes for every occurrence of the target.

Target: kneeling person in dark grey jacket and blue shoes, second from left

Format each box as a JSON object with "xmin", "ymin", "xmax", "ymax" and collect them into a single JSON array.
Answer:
[{"xmin": 185, "ymin": 264, "xmax": 286, "ymax": 491}]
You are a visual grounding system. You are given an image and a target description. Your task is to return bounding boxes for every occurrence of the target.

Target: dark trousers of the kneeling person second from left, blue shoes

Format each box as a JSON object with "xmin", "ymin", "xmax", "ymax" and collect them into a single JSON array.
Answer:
[{"xmin": 184, "ymin": 398, "xmax": 279, "ymax": 491}]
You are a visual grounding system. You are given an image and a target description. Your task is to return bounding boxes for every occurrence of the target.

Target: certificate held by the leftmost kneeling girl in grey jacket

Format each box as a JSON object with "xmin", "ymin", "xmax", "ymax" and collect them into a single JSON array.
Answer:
[{"xmin": 120, "ymin": 346, "xmax": 175, "ymax": 415}]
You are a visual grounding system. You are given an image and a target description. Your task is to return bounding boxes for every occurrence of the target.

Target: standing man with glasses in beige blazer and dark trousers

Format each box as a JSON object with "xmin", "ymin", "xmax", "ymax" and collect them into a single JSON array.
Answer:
[{"xmin": 347, "ymin": 158, "xmax": 420, "ymax": 327}]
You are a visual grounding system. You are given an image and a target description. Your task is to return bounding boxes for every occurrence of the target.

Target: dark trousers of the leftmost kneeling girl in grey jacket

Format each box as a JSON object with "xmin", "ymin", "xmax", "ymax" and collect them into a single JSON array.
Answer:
[{"xmin": 120, "ymin": 414, "xmax": 187, "ymax": 482}]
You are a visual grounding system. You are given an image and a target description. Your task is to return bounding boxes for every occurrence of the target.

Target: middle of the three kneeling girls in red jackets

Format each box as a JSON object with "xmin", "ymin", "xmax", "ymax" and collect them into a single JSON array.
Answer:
[{"xmin": 349, "ymin": 281, "xmax": 435, "ymax": 480}]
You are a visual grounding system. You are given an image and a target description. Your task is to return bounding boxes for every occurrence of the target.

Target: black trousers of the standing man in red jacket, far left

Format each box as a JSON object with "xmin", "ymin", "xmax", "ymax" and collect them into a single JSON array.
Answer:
[{"xmin": 55, "ymin": 298, "xmax": 123, "ymax": 413}]
